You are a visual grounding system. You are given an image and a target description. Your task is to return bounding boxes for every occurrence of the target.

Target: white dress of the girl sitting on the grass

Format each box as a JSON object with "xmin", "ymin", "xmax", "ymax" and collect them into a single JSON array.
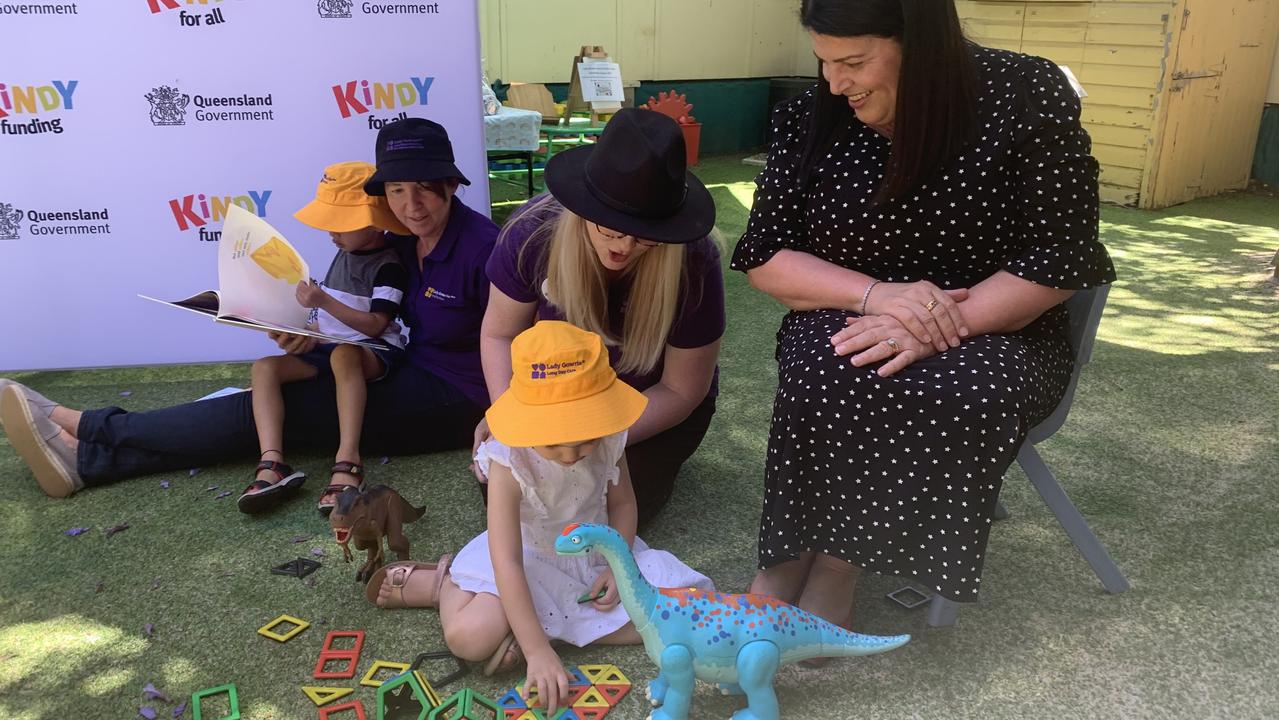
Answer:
[{"xmin": 450, "ymin": 431, "xmax": 714, "ymax": 647}]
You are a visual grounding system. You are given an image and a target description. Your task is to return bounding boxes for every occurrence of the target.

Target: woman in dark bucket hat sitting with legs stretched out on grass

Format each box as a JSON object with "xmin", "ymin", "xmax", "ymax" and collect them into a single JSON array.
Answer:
[{"xmin": 0, "ymin": 118, "xmax": 498, "ymax": 497}]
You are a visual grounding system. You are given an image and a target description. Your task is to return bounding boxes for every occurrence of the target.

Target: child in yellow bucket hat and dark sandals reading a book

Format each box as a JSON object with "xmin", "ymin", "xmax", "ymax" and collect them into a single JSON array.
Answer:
[{"xmin": 237, "ymin": 162, "xmax": 411, "ymax": 513}]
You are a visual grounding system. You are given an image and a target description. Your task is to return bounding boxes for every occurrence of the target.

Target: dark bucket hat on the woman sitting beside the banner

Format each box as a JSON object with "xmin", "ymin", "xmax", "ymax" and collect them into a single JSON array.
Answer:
[{"xmin": 365, "ymin": 118, "xmax": 471, "ymax": 194}]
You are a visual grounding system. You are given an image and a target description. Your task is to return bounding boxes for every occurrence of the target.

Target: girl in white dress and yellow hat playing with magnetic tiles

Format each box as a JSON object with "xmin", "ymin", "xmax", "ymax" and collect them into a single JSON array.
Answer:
[{"xmin": 366, "ymin": 321, "xmax": 714, "ymax": 698}]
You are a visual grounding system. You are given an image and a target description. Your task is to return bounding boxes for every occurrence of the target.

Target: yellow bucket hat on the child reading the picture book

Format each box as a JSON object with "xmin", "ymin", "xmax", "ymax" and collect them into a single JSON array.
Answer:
[{"xmin": 293, "ymin": 162, "xmax": 413, "ymax": 235}]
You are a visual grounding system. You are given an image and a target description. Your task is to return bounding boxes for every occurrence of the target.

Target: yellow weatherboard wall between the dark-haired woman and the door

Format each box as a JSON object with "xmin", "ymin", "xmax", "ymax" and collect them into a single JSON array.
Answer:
[{"xmin": 955, "ymin": 0, "xmax": 1174, "ymax": 205}]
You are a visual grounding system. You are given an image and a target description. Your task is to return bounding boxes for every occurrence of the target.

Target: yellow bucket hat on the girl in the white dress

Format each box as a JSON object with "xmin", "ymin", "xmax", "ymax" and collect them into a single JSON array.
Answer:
[{"xmin": 485, "ymin": 320, "xmax": 648, "ymax": 448}]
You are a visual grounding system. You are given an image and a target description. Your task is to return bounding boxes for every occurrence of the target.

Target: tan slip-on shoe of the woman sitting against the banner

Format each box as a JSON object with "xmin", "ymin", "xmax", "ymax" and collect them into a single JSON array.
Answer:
[{"xmin": 0, "ymin": 382, "xmax": 84, "ymax": 497}]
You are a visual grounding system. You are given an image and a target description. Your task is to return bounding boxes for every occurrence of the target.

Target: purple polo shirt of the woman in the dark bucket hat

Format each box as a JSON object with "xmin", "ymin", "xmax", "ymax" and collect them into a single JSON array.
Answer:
[{"xmin": 395, "ymin": 197, "xmax": 498, "ymax": 408}]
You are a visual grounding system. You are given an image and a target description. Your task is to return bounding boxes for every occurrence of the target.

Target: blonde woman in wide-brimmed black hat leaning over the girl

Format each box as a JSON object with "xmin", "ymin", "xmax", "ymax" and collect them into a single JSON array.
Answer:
[{"xmin": 476, "ymin": 109, "xmax": 724, "ymax": 523}]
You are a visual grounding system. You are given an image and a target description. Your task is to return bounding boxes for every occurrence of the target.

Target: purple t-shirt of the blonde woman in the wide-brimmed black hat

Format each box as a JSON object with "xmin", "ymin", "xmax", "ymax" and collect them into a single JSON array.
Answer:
[{"xmin": 486, "ymin": 197, "xmax": 725, "ymax": 396}]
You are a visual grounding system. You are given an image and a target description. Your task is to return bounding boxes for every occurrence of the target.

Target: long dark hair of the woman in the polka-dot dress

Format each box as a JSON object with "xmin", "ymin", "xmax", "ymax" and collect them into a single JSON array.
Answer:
[{"xmin": 799, "ymin": 0, "xmax": 977, "ymax": 203}]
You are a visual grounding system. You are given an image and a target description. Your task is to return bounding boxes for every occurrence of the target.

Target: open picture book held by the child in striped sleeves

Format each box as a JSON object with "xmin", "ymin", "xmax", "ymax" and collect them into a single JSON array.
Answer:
[{"xmin": 138, "ymin": 205, "xmax": 381, "ymax": 348}]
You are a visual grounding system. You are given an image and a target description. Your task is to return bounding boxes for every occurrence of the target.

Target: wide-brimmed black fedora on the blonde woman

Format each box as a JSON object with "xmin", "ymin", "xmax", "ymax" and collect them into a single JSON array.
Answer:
[{"xmin": 546, "ymin": 107, "xmax": 715, "ymax": 243}]
